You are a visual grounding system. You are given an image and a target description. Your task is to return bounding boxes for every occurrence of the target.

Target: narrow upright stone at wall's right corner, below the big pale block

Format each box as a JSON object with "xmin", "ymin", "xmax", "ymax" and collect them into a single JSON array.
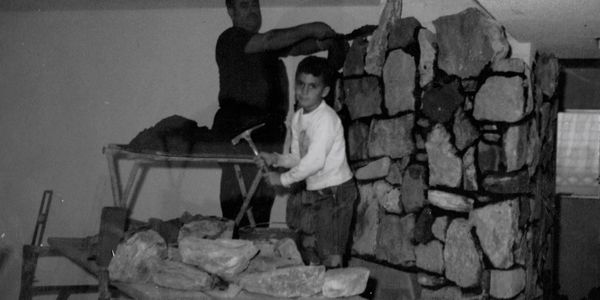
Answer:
[{"xmin": 502, "ymin": 122, "xmax": 529, "ymax": 172}]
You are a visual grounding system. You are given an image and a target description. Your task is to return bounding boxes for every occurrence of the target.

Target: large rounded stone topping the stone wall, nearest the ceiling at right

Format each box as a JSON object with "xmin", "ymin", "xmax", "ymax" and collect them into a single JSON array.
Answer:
[{"xmin": 433, "ymin": 8, "xmax": 510, "ymax": 78}]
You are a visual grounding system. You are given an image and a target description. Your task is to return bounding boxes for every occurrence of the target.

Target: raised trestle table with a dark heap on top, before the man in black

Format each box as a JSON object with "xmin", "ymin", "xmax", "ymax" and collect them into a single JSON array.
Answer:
[{"xmin": 102, "ymin": 144, "xmax": 263, "ymax": 227}]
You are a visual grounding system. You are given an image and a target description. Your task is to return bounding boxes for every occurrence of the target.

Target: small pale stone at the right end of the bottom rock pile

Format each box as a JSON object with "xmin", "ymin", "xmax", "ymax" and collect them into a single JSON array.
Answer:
[{"xmin": 323, "ymin": 267, "xmax": 370, "ymax": 298}]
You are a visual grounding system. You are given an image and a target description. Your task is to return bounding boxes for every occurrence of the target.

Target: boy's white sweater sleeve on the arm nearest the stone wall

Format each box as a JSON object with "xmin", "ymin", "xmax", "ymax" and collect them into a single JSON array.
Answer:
[{"xmin": 280, "ymin": 113, "xmax": 335, "ymax": 186}]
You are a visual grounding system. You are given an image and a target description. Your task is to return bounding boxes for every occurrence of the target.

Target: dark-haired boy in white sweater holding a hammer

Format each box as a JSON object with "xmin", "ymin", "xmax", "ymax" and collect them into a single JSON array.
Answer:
[{"xmin": 259, "ymin": 56, "xmax": 358, "ymax": 268}]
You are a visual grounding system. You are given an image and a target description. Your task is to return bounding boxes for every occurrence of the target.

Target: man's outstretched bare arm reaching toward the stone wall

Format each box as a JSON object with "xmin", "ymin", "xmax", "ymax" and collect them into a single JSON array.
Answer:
[{"xmin": 244, "ymin": 22, "xmax": 336, "ymax": 53}]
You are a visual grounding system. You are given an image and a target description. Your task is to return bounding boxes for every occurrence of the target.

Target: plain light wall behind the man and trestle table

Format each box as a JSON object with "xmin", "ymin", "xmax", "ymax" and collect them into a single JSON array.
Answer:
[{"xmin": 0, "ymin": 1, "xmax": 381, "ymax": 299}]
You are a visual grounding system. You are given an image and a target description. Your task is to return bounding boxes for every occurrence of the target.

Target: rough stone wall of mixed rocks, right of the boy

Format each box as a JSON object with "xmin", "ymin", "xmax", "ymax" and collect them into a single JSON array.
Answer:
[{"xmin": 343, "ymin": 1, "xmax": 559, "ymax": 299}]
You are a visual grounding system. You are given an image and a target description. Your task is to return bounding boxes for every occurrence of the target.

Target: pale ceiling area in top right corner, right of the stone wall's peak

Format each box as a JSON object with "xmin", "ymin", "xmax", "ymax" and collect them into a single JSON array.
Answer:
[{"xmin": 478, "ymin": 0, "xmax": 600, "ymax": 59}]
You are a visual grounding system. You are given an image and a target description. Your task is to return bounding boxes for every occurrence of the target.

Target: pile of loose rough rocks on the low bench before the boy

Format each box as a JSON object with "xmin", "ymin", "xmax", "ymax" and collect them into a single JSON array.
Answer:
[{"xmin": 108, "ymin": 219, "xmax": 369, "ymax": 298}]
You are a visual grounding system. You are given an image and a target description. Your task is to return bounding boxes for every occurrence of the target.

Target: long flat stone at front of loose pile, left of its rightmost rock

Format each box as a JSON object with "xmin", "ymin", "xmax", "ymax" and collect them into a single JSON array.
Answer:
[{"xmin": 239, "ymin": 266, "xmax": 325, "ymax": 298}]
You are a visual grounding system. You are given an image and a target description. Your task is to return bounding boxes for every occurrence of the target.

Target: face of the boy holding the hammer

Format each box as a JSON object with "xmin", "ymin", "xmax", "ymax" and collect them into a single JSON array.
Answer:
[{"xmin": 294, "ymin": 73, "xmax": 329, "ymax": 113}]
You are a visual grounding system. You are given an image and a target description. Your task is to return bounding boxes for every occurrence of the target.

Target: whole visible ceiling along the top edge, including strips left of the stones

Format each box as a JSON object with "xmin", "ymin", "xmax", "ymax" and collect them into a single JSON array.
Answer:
[{"xmin": 0, "ymin": 0, "xmax": 600, "ymax": 59}]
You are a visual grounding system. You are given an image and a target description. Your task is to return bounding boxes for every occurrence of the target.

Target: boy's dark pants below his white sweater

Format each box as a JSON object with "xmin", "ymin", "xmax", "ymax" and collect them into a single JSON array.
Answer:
[{"xmin": 287, "ymin": 179, "xmax": 358, "ymax": 263}]
